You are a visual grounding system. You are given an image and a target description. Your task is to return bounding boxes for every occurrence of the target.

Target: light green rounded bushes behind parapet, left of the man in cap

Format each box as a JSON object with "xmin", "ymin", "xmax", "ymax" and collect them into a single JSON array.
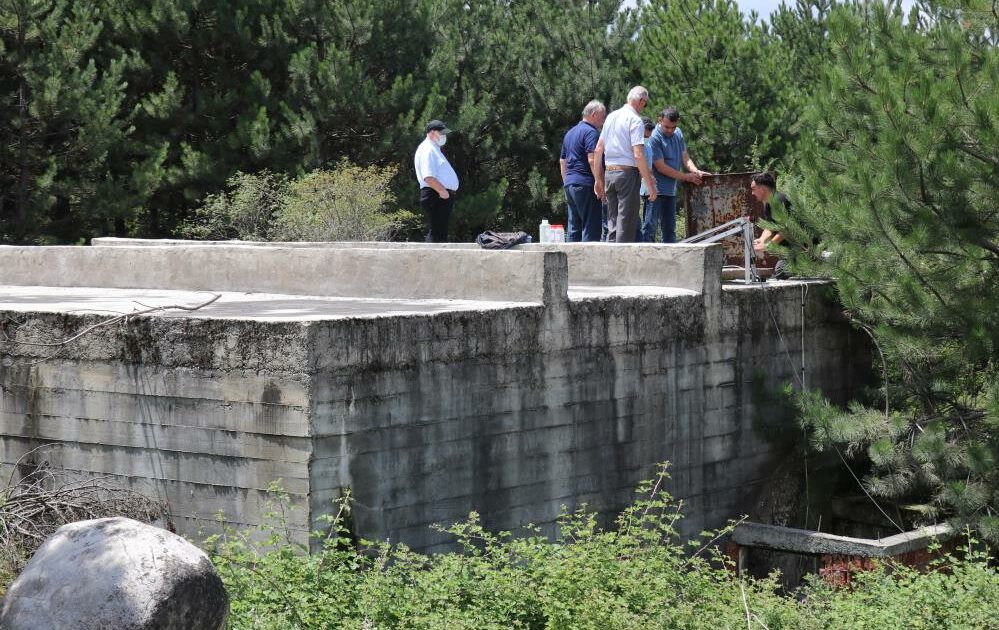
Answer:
[{"xmin": 180, "ymin": 161, "xmax": 415, "ymax": 241}]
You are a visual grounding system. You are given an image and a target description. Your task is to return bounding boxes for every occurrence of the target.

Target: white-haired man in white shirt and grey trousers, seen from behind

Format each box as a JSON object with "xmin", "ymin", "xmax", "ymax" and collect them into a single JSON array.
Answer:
[{"xmin": 593, "ymin": 85, "xmax": 657, "ymax": 243}]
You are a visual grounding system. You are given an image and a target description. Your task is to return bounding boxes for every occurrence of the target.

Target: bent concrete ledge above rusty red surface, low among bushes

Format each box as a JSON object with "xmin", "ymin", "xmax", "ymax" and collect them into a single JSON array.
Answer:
[{"xmin": 732, "ymin": 523, "xmax": 953, "ymax": 558}]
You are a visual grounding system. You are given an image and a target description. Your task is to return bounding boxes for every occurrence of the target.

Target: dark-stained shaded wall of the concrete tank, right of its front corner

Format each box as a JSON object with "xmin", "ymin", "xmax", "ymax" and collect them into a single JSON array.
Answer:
[{"xmin": 311, "ymin": 286, "xmax": 863, "ymax": 549}]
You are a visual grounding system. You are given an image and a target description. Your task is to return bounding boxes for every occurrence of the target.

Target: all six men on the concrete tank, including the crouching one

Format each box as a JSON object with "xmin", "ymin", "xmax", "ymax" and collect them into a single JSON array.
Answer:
[{"xmin": 414, "ymin": 85, "xmax": 790, "ymax": 277}]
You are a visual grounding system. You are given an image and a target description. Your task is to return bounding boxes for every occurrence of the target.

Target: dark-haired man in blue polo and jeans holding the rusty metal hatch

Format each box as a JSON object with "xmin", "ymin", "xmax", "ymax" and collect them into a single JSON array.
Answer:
[{"xmin": 642, "ymin": 106, "xmax": 710, "ymax": 243}]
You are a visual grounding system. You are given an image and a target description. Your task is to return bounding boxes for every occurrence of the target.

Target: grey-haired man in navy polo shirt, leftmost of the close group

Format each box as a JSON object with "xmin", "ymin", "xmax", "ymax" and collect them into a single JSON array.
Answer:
[{"xmin": 559, "ymin": 101, "xmax": 607, "ymax": 243}]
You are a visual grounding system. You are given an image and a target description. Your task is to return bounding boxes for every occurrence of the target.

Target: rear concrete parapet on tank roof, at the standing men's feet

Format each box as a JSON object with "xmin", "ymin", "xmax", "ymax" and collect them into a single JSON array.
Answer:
[{"xmin": 93, "ymin": 238, "xmax": 724, "ymax": 295}]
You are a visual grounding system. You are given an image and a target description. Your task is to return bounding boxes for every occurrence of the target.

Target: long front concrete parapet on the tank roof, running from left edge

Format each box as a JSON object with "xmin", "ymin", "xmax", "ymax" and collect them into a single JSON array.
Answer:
[{"xmin": 0, "ymin": 244, "xmax": 568, "ymax": 304}]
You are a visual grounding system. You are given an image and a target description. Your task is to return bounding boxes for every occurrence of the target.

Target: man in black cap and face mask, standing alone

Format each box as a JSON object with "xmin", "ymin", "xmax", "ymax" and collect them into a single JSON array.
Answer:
[{"xmin": 413, "ymin": 120, "xmax": 458, "ymax": 243}]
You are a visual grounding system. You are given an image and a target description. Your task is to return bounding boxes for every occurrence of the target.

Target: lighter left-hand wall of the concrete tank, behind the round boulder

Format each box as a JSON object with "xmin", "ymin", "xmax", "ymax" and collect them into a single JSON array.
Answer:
[{"xmin": 0, "ymin": 312, "xmax": 313, "ymax": 535}]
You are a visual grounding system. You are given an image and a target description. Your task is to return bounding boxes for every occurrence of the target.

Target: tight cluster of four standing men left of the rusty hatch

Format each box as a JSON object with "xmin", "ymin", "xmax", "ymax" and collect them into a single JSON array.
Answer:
[{"xmin": 559, "ymin": 86, "xmax": 710, "ymax": 243}]
